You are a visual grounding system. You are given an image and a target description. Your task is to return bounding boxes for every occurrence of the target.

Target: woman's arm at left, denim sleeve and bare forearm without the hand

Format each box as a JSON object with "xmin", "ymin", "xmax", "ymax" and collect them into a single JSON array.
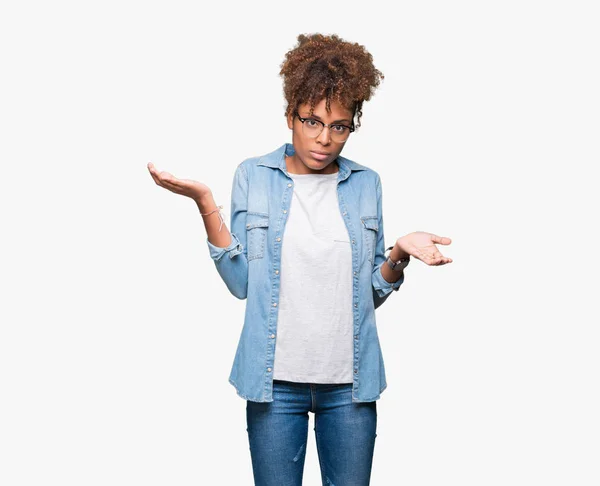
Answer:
[{"xmin": 198, "ymin": 164, "xmax": 248, "ymax": 299}]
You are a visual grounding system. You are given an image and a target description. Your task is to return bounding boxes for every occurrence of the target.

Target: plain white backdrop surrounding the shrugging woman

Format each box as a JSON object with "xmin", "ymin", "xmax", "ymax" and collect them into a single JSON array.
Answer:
[{"xmin": 0, "ymin": 0, "xmax": 600, "ymax": 486}]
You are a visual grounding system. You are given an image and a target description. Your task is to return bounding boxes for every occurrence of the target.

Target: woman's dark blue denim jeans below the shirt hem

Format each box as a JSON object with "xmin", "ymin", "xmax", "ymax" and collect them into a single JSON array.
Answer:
[{"xmin": 246, "ymin": 380, "xmax": 377, "ymax": 486}]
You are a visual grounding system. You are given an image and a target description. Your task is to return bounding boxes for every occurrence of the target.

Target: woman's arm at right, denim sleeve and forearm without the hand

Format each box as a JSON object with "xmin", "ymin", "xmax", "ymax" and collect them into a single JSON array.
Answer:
[{"xmin": 371, "ymin": 176, "xmax": 407, "ymax": 309}]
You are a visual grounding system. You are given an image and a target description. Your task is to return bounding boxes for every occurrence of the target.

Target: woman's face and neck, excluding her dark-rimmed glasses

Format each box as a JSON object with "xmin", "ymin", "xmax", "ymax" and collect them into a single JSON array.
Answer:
[{"xmin": 286, "ymin": 99, "xmax": 352, "ymax": 174}]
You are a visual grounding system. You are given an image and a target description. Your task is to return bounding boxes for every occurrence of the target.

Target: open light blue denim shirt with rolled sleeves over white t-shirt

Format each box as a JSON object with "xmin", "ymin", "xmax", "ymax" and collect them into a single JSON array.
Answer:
[{"xmin": 206, "ymin": 143, "xmax": 404, "ymax": 402}]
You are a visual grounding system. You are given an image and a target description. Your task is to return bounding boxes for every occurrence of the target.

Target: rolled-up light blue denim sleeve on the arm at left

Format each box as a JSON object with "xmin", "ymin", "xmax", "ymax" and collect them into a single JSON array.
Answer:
[{"xmin": 206, "ymin": 163, "xmax": 248, "ymax": 299}]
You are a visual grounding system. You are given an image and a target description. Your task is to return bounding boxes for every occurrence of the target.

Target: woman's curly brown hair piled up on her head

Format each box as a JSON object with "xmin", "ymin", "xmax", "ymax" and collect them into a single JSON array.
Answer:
[{"xmin": 279, "ymin": 34, "xmax": 384, "ymax": 128}]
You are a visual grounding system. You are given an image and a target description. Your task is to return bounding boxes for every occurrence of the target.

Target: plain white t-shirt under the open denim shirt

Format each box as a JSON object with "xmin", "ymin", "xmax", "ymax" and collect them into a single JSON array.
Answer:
[{"xmin": 273, "ymin": 172, "xmax": 354, "ymax": 383}]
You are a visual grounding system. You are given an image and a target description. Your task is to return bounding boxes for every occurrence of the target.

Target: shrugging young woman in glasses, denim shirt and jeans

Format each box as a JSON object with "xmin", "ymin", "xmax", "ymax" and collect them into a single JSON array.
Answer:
[{"xmin": 148, "ymin": 34, "xmax": 452, "ymax": 486}]
